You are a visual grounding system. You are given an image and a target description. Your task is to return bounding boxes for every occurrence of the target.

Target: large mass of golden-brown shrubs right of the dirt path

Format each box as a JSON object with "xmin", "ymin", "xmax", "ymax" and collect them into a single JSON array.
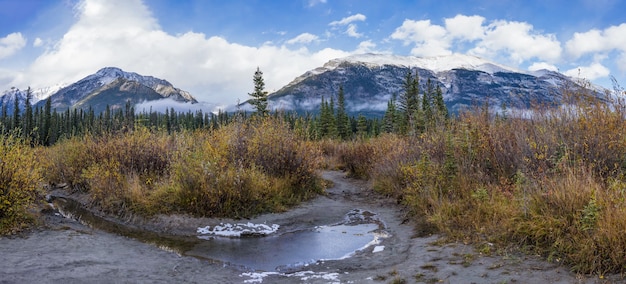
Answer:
[{"xmin": 342, "ymin": 88, "xmax": 626, "ymax": 275}]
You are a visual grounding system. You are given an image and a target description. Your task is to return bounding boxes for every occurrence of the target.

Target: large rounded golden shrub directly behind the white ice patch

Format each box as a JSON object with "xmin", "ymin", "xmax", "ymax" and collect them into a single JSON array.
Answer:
[{"xmin": 162, "ymin": 118, "xmax": 321, "ymax": 217}]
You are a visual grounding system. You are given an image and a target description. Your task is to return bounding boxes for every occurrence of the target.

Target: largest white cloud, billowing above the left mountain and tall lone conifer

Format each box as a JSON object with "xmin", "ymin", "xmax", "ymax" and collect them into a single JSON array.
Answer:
[{"xmin": 11, "ymin": 0, "xmax": 349, "ymax": 104}]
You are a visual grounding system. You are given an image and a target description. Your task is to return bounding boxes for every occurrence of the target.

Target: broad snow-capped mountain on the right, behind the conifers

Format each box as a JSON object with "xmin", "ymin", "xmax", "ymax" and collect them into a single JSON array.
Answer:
[{"xmin": 269, "ymin": 53, "xmax": 600, "ymax": 116}]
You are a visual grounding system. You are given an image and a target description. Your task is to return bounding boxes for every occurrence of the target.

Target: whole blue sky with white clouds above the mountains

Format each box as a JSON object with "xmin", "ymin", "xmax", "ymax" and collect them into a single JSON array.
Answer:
[{"xmin": 0, "ymin": 0, "xmax": 626, "ymax": 106}]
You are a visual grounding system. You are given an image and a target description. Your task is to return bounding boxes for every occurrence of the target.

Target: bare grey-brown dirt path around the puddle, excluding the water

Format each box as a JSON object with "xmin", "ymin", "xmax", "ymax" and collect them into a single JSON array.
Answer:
[{"xmin": 0, "ymin": 172, "xmax": 620, "ymax": 283}]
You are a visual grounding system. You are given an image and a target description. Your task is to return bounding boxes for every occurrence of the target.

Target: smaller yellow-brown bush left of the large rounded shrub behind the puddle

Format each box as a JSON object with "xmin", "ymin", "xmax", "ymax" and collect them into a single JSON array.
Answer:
[{"xmin": 45, "ymin": 128, "xmax": 174, "ymax": 214}]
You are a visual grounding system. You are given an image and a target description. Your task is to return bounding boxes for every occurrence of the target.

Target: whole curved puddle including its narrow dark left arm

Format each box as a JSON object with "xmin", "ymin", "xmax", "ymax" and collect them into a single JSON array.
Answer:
[{"xmin": 53, "ymin": 198, "xmax": 385, "ymax": 271}]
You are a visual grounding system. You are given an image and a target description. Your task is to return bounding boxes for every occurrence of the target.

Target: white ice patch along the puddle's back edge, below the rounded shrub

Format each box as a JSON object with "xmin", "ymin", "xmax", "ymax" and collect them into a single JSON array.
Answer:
[{"xmin": 197, "ymin": 222, "xmax": 280, "ymax": 237}]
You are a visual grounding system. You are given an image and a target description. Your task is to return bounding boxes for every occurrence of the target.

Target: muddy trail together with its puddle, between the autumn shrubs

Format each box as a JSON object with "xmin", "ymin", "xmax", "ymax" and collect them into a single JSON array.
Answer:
[{"xmin": 0, "ymin": 171, "xmax": 622, "ymax": 283}]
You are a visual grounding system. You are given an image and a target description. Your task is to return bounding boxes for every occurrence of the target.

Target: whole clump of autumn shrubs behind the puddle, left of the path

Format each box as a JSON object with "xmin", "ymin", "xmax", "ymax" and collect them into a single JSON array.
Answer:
[{"xmin": 47, "ymin": 118, "xmax": 321, "ymax": 217}]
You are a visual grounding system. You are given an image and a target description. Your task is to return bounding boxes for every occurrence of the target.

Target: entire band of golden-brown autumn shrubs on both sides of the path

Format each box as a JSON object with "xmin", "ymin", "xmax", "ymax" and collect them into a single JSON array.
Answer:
[{"xmin": 0, "ymin": 84, "xmax": 626, "ymax": 275}]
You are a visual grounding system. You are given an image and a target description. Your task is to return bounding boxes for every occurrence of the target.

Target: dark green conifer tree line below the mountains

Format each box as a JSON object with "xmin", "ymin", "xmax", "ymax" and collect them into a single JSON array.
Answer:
[{"xmin": 0, "ymin": 68, "xmax": 449, "ymax": 146}]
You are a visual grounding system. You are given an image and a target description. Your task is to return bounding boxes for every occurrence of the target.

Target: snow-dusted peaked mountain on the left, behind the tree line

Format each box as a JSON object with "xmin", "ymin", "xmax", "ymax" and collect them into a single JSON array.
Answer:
[{"xmin": 0, "ymin": 67, "xmax": 198, "ymax": 113}]
